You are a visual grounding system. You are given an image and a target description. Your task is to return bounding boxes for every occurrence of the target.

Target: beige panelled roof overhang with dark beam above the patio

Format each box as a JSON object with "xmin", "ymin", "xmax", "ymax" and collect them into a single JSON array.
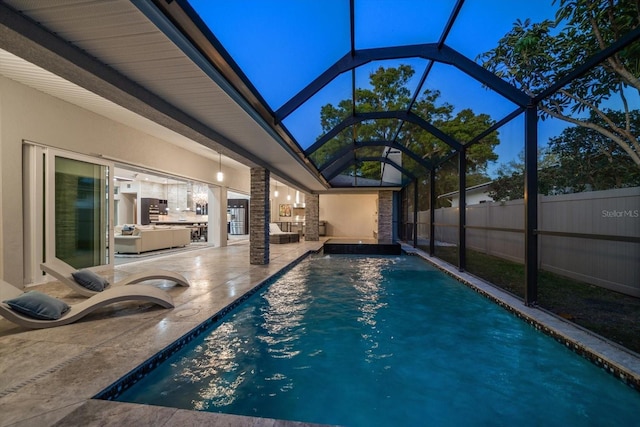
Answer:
[{"xmin": 0, "ymin": 0, "xmax": 327, "ymax": 192}]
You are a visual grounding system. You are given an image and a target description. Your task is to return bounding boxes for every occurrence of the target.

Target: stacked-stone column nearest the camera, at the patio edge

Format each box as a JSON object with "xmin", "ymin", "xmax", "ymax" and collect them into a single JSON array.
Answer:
[{"xmin": 249, "ymin": 168, "xmax": 271, "ymax": 265}]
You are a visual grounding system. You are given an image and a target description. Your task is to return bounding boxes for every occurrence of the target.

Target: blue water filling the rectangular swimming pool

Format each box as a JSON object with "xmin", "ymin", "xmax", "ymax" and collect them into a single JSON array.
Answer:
[{"xmin": 118, "ymin": 255, "xmax": 640, "ymax": 427}]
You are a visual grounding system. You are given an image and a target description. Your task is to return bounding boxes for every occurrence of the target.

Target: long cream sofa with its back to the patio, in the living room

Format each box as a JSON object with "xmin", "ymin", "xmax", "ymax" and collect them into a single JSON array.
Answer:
[{"xmin": 114, "ymin": 225, "xmax": 191, "ymax": 254}]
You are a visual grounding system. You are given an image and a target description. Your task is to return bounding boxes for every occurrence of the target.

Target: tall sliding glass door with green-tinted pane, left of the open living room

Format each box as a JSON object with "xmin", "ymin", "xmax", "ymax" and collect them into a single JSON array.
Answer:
[{"xmin": 23, "ymin": 141, "xmax": 113, "ymax": 283}]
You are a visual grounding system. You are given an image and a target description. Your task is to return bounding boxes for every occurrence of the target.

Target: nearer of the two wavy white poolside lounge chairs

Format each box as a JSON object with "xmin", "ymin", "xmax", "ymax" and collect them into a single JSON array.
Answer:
[{"xmin": 0, "ymin": 280, "xmax": 173, "ymax": 329}]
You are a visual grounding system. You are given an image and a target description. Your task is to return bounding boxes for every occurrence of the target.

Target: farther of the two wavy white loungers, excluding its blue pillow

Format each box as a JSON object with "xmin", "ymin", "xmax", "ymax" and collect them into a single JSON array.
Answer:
[{"xmin": 40, "ymin": 258, "xmax": 189, "ymax": 297}]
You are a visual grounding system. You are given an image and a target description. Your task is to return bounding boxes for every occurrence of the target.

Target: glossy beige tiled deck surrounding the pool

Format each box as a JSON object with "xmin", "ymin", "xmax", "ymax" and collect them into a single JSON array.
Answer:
[{"xmin": 0, "ymin": 239, "xmax": 640, "ymax": 427}]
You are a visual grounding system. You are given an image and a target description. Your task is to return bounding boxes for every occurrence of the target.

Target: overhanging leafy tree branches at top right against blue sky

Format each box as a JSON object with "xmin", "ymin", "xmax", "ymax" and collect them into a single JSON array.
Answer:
[{"xmin": 479, "ymin": 0, "xmax": 640, "ymax": 168}]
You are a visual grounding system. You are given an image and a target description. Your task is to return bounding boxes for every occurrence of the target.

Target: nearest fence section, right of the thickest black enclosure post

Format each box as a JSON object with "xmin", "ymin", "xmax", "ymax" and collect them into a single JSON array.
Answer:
[{"xmin": 538, "ymin": 187, "xmax": 640, "ymax": 297}]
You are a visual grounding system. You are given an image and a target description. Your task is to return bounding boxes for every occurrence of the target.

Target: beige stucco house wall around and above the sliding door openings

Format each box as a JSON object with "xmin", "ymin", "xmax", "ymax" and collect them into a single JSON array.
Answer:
[{"xmin": 0, "ymin": 76, "xmax": 250, "ymax": 284}]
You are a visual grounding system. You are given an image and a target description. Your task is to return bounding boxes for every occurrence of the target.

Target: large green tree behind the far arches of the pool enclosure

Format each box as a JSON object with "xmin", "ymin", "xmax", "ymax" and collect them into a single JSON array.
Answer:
[{"xmin": 318, "ymin": 65, "xmax": 499, "ymax": 191}]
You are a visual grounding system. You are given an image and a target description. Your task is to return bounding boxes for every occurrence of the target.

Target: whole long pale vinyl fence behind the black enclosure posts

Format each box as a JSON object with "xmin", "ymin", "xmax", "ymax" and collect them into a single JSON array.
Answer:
[{"xmin": 409, "ymin": 187, "xmax": 640, "ymax": 297}]
